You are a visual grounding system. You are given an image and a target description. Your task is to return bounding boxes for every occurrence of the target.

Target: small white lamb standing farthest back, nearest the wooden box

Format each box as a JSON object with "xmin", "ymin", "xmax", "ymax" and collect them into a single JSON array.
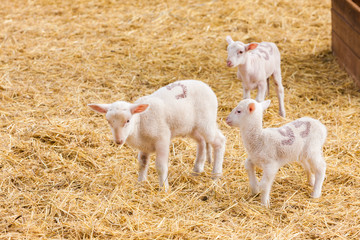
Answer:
[{"xmin": 226, "ymin": 36, "xmax": 285, "ymax": 117}]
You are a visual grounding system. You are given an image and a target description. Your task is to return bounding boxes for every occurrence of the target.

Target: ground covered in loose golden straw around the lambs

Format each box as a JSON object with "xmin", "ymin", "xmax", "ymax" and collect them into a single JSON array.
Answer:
[{"xmin": 0, "ymin": 0, "xmax": 360, "ymax": 239}]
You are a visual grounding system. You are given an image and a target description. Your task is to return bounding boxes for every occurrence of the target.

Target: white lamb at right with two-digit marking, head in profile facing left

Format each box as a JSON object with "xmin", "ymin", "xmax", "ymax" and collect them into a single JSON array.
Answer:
[{"xmin": 226, "ymin": 99, "xmax": 327, "ymax": 207}]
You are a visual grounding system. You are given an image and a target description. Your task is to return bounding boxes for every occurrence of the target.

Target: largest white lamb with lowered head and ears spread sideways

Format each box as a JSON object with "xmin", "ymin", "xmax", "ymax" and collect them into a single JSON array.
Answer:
[{"xmin": 88, "ymin": 80, "xmax": 226, "ymax": 191}]
